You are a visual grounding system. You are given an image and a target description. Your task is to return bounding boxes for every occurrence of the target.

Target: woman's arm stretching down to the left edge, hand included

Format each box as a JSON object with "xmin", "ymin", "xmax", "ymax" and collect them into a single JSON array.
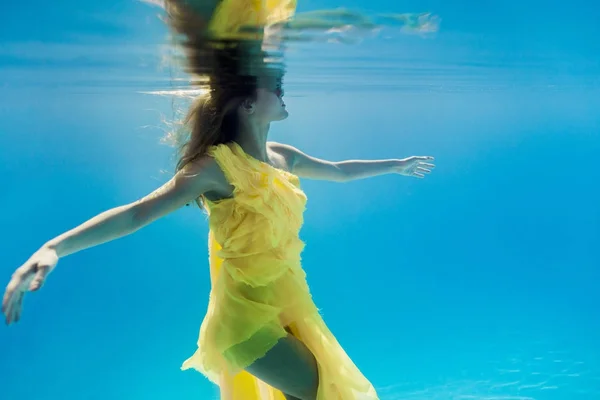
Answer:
[{"xmin": 2, "ymin": 157, "xmax": 222, "ymax": 324}]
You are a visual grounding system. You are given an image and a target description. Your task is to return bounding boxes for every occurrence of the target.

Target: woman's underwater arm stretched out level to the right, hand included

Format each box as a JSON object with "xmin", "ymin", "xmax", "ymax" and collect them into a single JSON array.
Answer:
[{"xmin": 269, "ymin": 142, "xmax": 434, "ymax": 182}]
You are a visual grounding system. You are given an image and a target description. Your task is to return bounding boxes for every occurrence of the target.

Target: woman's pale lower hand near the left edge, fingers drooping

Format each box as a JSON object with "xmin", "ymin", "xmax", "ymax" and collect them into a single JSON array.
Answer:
[{"xmin": 2, "ymin": 247, "xmax": 58, "ymax": 325}]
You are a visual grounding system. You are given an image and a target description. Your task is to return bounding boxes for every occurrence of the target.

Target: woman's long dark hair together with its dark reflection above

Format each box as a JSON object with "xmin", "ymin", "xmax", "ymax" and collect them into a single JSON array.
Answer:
[{"xmin": 163, "ymin": 0, "xmax": 274, "ymax": 178}]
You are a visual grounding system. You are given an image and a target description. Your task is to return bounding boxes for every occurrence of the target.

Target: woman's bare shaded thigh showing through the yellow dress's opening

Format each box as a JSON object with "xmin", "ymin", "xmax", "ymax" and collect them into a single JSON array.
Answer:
[{"xmin": 246, "ymin": 334, "xmax": 319, "ymax": 400}]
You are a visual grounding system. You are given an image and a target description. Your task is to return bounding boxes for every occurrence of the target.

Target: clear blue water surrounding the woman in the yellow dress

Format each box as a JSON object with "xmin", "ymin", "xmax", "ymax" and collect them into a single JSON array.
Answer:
[{"xmin": 0, "ymin": 0, "xmax": 600, "ymax": 400}]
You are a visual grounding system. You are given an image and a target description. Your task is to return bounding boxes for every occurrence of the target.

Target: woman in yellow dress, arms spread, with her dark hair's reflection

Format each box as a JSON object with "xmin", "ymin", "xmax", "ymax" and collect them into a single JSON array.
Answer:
[{"xmin": 2, "ymin": 2, "xmax": 433, "ymax": 400}]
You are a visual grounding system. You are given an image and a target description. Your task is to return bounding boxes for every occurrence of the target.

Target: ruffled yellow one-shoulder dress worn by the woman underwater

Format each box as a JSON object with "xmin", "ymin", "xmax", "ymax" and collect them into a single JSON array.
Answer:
[{"xmin": 182, "ymin": 143, "xmax": 378, "ymax": 400}]
